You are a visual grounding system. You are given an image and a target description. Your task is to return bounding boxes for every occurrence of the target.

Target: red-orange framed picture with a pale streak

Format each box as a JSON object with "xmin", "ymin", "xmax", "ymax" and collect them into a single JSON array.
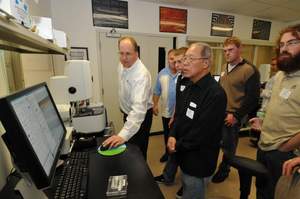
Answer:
[{"xmin": 159, "ymin": 7, "xmax": 187, "ymax": 33}]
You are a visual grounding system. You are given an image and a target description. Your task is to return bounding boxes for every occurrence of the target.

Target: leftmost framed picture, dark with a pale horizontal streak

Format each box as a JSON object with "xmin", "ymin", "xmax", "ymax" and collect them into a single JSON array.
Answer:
[{"xmin": 92, "ymin": 0, "xmax": 128, "ymax": 29}]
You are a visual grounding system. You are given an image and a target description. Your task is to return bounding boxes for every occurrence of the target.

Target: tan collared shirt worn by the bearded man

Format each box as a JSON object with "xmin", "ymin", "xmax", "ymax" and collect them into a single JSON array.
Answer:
[{"xmin": 259, "ymin": 71, "xmax": 300, "ymax": 151}]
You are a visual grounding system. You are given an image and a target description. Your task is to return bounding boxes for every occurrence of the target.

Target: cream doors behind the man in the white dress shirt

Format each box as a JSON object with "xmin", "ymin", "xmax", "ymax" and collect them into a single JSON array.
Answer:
[{"xmin": 99, "ymin": 32, "xmax": 173, "ymax": 132}]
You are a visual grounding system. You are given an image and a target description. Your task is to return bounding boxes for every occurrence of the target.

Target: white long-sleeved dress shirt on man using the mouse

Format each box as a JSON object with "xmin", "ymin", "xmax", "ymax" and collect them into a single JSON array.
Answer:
[{"xmin": 118, "ymin": 59, "xmax": 153, "ymax": 141}]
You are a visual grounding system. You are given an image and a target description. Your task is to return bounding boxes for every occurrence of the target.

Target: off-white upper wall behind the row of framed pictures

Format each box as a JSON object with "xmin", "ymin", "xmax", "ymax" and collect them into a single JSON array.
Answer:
[{"xmin": 51, "ymin": 0, "xmax": 284, "ymax": 101}]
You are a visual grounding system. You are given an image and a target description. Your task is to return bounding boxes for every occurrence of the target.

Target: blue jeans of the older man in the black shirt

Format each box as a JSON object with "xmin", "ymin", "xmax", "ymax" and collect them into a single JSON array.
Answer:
[{"xmin": 182, "ymin": 172, "xmax": 206, "ymax": 199}]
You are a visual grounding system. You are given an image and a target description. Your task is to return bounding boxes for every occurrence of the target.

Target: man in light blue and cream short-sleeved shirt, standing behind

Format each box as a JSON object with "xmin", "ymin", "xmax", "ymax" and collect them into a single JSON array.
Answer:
[{"xmin": 153, "ymin": 49, "xmax": 177, "ymax": 162}]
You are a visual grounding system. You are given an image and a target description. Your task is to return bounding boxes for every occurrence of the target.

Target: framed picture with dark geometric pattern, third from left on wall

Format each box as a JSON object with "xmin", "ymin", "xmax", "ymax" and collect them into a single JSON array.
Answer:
[{"xmin": 210, "ymin": 13, "xmax": 234, "ymax": 37}]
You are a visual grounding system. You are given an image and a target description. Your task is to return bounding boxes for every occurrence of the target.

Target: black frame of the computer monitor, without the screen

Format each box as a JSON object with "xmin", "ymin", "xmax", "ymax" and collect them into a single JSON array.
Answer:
[{"xmin": 0, "ymin": 82, "xmax": 66, "ymax": 189}]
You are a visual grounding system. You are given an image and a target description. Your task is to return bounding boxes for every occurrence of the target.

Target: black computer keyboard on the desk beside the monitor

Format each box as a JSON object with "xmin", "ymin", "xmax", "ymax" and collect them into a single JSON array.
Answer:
[{"xmin": 54, "ymin": 152, "xmax": 89, "ymax": 199}]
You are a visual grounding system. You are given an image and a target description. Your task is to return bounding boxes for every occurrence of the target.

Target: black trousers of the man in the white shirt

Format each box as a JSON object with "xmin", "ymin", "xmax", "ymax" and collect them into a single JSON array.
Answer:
[{"xmin": 123, "ymin": 108, "xmax": 153, "ymax": 160}]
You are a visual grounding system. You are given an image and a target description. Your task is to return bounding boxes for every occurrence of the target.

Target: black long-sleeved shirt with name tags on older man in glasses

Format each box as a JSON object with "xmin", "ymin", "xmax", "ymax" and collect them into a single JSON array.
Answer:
[{"xmin": 170, "ymin": 74, "xmax": 226, "ymax": 177}]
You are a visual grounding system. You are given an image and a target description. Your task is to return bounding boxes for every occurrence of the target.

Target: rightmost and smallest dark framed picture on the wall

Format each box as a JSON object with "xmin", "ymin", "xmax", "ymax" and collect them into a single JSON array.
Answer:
[{"xmin": 252, "ymin": 19, "xmax": 272, "ymax": 40}]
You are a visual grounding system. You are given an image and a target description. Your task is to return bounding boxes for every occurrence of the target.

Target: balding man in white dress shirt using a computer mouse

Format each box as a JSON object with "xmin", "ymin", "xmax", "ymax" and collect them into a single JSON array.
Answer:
[{"xmin": 103, "ymin": 37, "xmax": 153, "ymax": 159}]
